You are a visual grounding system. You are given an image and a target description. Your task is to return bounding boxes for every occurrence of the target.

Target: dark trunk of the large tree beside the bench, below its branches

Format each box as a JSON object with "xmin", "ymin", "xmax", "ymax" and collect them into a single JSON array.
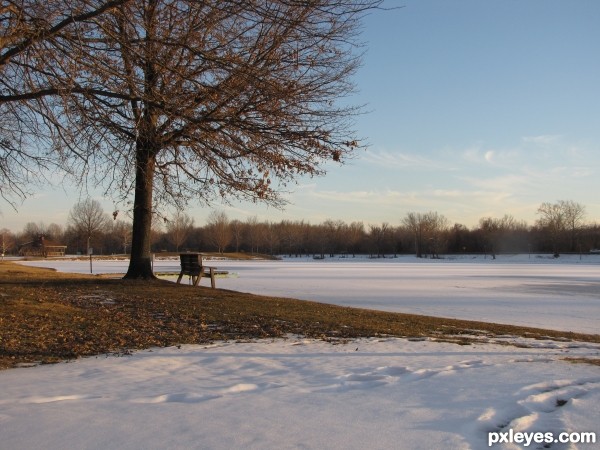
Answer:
[{"xmin": 125, "ymin": 144, "xmax": 156, "ymax": 280}]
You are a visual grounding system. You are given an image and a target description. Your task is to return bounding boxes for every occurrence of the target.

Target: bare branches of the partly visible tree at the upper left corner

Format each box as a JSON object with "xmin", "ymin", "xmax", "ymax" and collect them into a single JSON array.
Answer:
[{"xmin": 0, "ymin": 0, "xmax": 130, "ymax": 206}]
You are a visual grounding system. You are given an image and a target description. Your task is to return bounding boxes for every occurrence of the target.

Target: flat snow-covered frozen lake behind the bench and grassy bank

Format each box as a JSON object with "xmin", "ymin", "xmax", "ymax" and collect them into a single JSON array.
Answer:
[{"xmin": 19, "ymin": 255, "xmax": 600, "ymax": 334}]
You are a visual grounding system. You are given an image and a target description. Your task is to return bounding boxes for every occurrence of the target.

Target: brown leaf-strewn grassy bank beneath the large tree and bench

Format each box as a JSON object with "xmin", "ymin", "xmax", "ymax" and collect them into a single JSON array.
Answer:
[{"xmin": 0, "ymin": 262, "xmax": 600, "ymax": 368}]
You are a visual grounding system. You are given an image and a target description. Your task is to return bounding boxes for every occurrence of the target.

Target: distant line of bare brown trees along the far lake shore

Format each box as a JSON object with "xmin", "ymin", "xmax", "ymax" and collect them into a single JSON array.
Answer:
[{"xmin": 0, "ymin": 201, "xmax": 600, "ymax": 257}]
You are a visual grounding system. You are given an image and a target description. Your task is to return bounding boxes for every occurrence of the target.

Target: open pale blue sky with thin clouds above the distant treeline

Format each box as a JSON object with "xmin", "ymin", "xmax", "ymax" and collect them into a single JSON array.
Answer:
[{"xmin": 0, "ymin": 0, "xmax": 600, "ymax": 231}]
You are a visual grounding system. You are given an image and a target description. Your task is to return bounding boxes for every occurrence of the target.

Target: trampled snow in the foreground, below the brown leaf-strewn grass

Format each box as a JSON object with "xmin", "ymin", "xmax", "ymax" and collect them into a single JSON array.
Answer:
[{"xmin": 0, "ymin": 337, "xmax": 600, "ymax": 450}]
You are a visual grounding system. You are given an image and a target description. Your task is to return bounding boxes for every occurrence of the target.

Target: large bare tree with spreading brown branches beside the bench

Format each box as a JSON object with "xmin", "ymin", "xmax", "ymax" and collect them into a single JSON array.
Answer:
[{"xmin": 0, "ymin": 0, "xmax": 382, "ymax": 278}]
